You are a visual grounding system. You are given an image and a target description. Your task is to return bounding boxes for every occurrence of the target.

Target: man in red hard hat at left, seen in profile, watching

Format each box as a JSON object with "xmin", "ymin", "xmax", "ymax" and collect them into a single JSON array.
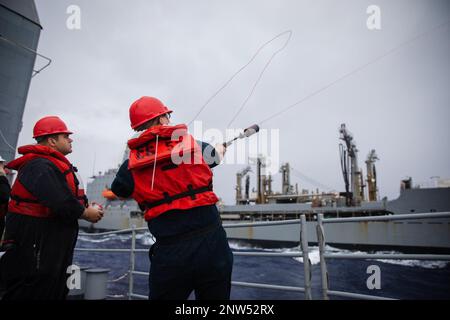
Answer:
[{"xmin": 0, "ymin": 116, "xmax": 103, "ymax": 300}]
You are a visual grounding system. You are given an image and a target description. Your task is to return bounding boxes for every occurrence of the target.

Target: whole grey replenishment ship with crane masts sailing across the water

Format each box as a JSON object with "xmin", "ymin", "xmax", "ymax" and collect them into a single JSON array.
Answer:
[{"xmin": 80, "ymin": 124, "xmax": 450, "ymax": 252}]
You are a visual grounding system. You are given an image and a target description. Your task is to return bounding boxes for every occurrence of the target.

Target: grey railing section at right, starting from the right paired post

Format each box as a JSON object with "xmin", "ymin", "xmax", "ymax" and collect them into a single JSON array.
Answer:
[{"xmin": 316, "ymin": 212, "xmax": 450, "ymax": 300}]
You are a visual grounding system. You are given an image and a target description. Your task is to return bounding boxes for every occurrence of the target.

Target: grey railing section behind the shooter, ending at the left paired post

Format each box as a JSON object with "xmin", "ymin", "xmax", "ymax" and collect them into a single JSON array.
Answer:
[{"xmin": 75, "ymin": 214, "xmax": 312, "ymax": 300}]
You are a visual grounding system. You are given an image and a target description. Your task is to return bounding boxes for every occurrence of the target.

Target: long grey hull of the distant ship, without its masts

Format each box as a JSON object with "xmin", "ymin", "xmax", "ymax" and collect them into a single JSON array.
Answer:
[{"xmin": 80, "ymin": 188, "xmax": 450, "ymax": 252}]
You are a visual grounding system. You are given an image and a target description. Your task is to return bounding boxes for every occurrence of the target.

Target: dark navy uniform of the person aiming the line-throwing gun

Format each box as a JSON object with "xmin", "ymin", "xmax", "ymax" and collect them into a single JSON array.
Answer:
[{"xmin": 111, "ymin": 142, "xmax": 233, "ymax": 300}]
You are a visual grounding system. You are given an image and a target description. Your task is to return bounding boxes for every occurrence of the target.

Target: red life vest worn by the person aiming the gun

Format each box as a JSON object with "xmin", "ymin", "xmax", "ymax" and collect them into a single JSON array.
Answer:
[{"xmin": 128, "ymin": 125, "xmax": 218, "ymax": 221}]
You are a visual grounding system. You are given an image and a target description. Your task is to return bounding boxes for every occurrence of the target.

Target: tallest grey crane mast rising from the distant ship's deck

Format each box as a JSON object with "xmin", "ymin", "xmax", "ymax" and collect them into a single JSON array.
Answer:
[{"xmin": 339, "ymin": 123, "xmax": 364, "ymax": 205}]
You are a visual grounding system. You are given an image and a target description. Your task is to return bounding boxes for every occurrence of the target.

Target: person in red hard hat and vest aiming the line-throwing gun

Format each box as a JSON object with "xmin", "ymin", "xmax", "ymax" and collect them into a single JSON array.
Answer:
[{"xmin": 111, "ymin": 97, "xmax": 233, "ymax": 300}]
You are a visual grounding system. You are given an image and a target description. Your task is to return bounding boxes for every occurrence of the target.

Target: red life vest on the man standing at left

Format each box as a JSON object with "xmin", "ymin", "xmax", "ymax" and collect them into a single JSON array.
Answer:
[{"xmin": 7, "ymin": 145, "xmax": 87, "ymax": 218}]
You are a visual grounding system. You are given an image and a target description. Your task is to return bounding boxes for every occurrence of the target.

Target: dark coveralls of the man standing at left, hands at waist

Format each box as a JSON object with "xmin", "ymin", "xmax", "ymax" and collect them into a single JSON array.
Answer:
[{"xmin": 0, "ymin": 158, "xmax": 84, "ymax": 300}]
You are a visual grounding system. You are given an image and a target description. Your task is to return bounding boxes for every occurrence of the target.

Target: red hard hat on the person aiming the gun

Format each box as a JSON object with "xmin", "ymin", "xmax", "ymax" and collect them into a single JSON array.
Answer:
[{"xmin": 130, "ymin": 97, "xmax": 172, "ymax": 129}]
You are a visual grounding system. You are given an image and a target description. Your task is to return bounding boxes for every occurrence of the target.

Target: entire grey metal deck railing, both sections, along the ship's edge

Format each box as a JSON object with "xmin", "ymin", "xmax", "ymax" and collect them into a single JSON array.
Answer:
[{"xmin": 76, "ymin": 212, "xmax": 450, "ymax": 300}]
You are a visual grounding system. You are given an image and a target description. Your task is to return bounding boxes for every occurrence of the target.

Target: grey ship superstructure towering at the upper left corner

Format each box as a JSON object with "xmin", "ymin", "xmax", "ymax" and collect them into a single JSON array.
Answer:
[{"xmin": 0, "ymin": 0, "xmax": 43, "ymax": 165}]
